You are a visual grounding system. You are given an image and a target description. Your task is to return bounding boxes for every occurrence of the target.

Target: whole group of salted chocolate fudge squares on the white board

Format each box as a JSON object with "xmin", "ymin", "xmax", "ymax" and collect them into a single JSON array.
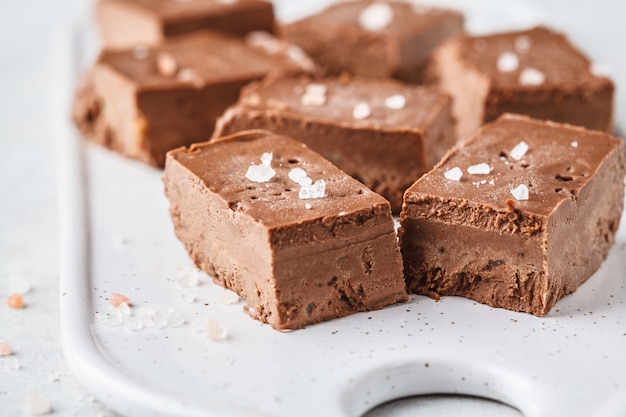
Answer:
[{"xmin": 73, "ymin": 0, "xmax": 626, "ymax": 330}]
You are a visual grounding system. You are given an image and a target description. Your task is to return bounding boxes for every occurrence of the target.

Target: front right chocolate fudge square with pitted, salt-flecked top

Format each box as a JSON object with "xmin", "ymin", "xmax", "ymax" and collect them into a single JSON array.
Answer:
[{"xmin": 399, "ymin": 115, "xmax": 626, "ymax": 316}]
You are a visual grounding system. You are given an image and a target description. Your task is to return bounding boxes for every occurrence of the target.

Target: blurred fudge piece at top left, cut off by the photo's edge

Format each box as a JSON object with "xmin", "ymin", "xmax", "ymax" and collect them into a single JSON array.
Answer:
[{"xmin": 96, "ymin": 0, "xmax": 274, "ymax": 48}]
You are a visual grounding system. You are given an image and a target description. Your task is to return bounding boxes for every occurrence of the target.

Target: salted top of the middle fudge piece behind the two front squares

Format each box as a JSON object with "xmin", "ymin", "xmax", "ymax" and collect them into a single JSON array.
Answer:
[{"xmin": 225, "ymin": 77, "xmax": 450, "ymax": 131}]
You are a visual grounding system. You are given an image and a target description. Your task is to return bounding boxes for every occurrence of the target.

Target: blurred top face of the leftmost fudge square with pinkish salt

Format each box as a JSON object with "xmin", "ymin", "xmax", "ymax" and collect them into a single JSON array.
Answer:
[{"xmin": 98, "ymin": 31, "xmax": 306, "ymax": 88}]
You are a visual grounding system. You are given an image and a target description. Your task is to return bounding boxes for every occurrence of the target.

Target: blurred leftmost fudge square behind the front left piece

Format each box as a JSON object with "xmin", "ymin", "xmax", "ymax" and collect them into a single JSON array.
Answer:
[{"xmin": 73, "ymin": 32, "xmax": 306, "ymax": 166}]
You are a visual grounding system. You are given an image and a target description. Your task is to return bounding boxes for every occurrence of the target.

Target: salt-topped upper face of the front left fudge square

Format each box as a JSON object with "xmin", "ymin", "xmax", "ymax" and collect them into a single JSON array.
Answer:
[{"xmin": 168, "ymin": 130, "xmax": 391, "ymax": 228}]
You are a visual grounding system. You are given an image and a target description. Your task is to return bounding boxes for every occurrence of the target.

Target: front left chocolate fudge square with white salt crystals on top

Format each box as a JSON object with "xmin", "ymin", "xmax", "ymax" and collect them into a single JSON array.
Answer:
[{"xmin": 163, "ymin": 130, "xmax": 407, "ymax": 330}]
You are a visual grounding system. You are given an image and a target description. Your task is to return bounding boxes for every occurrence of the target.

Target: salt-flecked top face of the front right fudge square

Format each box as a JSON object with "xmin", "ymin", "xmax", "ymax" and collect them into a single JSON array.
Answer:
[{"xmin": 405, "ymin": 114, "xmax": 623, "ymax": 216}]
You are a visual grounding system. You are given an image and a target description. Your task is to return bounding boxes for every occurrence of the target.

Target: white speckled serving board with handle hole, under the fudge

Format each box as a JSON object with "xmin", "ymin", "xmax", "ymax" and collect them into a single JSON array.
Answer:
[{"xmin": 55, "ymin": 1, "xmax": 626, "ymax": 417}]
